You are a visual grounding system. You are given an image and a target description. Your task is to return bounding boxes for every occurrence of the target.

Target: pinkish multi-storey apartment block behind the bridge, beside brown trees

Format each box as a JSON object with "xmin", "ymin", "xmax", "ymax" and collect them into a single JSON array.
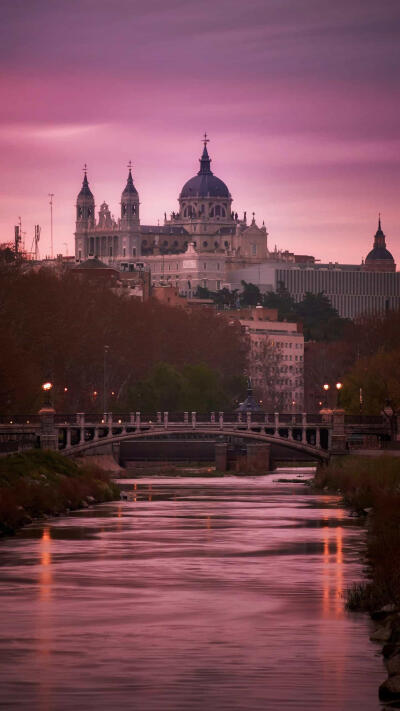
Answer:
[{"xmin": 229, "ymin": 306, "xmax": 304, "ymax": 412}]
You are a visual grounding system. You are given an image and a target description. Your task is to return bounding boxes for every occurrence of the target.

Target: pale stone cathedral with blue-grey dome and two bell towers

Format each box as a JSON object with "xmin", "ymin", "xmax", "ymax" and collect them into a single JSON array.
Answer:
[{"xmin": 75, "ymin": 134, "xmax": 270, "ymax": 272}]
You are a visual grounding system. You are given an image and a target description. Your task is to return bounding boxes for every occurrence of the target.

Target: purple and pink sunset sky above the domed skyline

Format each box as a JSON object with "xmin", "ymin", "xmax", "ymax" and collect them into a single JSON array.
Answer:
[{"xmin": 0, "ymin": 0, "xmax": 400, "ymax": 263}]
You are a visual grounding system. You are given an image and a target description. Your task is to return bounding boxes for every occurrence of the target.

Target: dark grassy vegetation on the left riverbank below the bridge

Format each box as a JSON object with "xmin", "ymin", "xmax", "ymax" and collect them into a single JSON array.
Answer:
[{"xmin": 0, "ymin": 450, "xmax": 119, "ymax": 535}]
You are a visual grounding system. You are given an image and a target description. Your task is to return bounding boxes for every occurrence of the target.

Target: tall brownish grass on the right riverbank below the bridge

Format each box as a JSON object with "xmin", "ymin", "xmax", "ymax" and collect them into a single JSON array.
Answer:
[{"xmin": 314, "ymin": 456, "xmax": 400, "ymax": 611}]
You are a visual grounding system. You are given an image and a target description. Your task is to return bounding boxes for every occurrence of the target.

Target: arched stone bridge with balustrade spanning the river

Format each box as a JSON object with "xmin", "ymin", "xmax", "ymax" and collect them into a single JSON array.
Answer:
[{"xmin": 0, "ymin": 406, "xmax": 390, "ymax": 470}]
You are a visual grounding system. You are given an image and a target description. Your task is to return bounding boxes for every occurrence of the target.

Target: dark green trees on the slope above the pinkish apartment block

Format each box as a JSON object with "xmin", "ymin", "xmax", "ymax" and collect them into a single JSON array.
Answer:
[{"xmin": 197, "ymin": 281, "xmax": 349, "ymax": 341}]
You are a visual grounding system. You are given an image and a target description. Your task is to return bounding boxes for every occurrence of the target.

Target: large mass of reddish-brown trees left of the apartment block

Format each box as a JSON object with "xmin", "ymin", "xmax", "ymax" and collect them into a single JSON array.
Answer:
[{"xmin": 0, "ymin": 264, "xmax": 248, "ymax": 414}]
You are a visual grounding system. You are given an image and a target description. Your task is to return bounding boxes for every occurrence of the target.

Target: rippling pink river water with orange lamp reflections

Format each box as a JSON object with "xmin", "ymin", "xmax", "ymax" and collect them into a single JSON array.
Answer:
[{"xmin": 0, "ymin": 470, "xmax": 385, "ymax": 711}]
